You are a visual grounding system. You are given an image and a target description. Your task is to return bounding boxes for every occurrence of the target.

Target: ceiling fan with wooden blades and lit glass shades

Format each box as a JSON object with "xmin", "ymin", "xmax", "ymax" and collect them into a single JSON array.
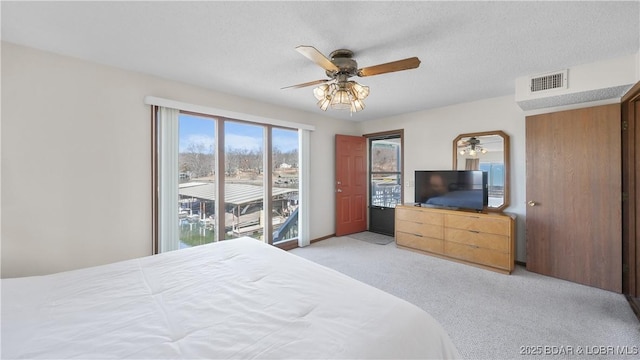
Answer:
[{"xmin": 282, "ymin": 45, "xmax": 420, "ymax": 113}]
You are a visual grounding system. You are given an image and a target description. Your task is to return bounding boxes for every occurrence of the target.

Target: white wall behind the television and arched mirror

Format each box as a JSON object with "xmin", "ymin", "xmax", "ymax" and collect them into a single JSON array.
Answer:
[{"xmin": 360, "ymin": 95, "xmax": 526, "ymax": 261}]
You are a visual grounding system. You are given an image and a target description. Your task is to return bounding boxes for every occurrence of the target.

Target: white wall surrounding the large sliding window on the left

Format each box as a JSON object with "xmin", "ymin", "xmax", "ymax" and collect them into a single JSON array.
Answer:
[{"xmin": 1, "ymin": 42, "xmax": 356, "ymax": 278}]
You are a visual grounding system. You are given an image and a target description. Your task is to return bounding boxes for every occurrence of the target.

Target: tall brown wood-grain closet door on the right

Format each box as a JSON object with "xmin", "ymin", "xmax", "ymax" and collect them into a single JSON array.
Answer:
[{"xmin": 526, "ymin": 104, "xmax": 622, "ymax": 292}]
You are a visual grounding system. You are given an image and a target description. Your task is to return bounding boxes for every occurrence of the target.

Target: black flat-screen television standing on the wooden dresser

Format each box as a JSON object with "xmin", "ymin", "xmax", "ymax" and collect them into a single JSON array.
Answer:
[{"xmin": 415, "ymin": 170, "xmax": 489, "ymax": 211}]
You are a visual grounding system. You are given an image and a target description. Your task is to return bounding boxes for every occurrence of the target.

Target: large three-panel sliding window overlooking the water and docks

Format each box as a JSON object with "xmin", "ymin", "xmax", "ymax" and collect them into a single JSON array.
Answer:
[{"xmin": 153, "ymin": 100, "xmax": 308, "ymax": 252}]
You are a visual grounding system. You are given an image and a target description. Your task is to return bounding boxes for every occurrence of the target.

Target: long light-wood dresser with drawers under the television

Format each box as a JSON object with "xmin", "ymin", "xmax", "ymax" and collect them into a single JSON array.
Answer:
[{"xmin": 395, "ymin": 205, "xmax": 515, "ymax": 274}]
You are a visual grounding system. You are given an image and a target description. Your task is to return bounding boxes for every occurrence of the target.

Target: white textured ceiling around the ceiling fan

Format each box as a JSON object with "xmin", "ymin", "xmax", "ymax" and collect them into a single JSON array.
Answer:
[{"xmin": 1, "ymin": 1, "xmax": 640, "ymax": 121}]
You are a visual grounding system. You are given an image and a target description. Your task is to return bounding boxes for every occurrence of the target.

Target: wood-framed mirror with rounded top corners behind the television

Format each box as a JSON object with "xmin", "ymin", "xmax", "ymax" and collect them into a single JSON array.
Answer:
[{"xmin": 453, "ymin": 130, "xmax": 510, "ymax": 211}]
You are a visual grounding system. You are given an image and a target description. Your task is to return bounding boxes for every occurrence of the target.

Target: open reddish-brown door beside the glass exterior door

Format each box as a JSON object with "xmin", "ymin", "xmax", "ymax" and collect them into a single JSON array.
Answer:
[{"xmin": 335, "ymin": 135, "xmax": 367, "ymax": 236}]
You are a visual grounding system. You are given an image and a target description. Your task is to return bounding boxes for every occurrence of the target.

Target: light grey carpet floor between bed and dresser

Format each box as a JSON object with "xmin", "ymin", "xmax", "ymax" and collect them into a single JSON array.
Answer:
[{"xmin": 290, "ymin": 236, "xmax": 640, "ymax": 359}]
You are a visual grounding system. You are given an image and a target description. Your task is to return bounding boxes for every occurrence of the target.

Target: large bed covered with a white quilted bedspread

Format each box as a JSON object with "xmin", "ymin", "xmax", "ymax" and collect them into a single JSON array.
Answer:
[{"xmin": 1, "ymin": 237, "xmax": 459, "ymax": 359}]
